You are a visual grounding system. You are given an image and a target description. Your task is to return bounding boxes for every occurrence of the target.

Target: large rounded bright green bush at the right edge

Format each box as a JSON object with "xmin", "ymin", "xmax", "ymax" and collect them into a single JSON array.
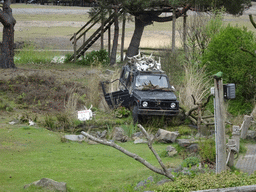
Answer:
[{"xmin": 203, "ymin": 26, "xmax": 256, "ymax": 102}]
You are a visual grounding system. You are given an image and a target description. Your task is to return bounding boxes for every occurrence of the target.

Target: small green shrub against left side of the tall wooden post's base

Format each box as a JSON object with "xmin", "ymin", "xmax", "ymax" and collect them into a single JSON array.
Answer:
[{"xmin": 198, "ymin": 138, "xmax": 216, "ymax": 163}]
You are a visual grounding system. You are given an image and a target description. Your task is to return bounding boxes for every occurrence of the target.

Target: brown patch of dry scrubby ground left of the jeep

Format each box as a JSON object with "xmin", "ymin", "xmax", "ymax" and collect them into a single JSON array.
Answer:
[{"xmin": 0, "ymin": 73, "xmax": 87, "ymax": 112}]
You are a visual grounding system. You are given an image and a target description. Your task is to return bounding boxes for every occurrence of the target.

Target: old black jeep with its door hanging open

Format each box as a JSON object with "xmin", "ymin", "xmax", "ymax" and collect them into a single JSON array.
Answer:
[{"xmin": 101, "ymin": 57, "xmax": 179, "ymax": 123}]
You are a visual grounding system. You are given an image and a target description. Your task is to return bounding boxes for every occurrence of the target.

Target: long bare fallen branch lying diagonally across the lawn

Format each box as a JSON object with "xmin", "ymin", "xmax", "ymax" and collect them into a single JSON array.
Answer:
[{"xmin": 81, "ymin": 131, "xmax": 173, "ymax": 180}]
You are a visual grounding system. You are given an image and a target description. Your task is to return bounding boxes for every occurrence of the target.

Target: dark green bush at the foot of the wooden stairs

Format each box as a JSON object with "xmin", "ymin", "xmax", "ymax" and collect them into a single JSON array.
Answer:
[{"xmin": 77, "ymin": 49, "xmax": 109, "ymax": 66}]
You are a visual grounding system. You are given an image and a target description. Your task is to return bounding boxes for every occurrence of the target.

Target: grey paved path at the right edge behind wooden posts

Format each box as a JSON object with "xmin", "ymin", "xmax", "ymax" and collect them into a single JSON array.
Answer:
[{"xmin": 235, "ymin": 144, "xmax": 256, "ymax": 174}]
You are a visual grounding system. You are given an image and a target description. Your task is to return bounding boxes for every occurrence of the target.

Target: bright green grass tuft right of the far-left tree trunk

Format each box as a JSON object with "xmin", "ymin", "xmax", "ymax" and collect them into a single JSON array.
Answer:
[{"xmin": 14, "ymin": 44, "xmax": 56, "ymax": 64}]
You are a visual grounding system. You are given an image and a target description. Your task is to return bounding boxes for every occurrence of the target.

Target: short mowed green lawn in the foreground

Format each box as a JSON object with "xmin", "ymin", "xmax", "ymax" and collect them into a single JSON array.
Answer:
[{"xmin": 0, "ymin": 125, "xmax": 181, "ymax": 191}]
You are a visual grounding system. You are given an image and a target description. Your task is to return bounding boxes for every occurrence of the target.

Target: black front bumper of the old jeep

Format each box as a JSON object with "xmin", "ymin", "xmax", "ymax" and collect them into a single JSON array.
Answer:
[{"xmin": 138, "ymin": 109, "xmax": 179, "ymax": 116}]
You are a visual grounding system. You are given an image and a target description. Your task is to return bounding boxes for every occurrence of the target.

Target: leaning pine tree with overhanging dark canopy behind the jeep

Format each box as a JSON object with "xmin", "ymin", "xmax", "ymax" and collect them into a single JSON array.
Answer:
[{"xmin": 122, "ymin": 0, "xmax": 251, "ymax": 57}]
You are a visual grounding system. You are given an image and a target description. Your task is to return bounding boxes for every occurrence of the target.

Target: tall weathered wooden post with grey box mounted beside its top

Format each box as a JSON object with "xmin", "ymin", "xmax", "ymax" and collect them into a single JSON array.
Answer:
[{"xmin": 214, "ymin": 72, "xmax": 226, "ymax": 173}]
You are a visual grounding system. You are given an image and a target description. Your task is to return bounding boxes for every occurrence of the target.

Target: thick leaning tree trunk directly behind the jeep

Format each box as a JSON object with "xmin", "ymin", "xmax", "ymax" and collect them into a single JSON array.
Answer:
[{"xmin": 126, "ymin": 17, "xmax": 145, "ymax": 57}]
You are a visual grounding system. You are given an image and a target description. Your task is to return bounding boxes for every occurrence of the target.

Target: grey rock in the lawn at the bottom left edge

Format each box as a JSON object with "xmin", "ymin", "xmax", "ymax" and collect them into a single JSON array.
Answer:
[{"xmin": 24, "ymin": 178, "xmax": 67, "ymax": 192}]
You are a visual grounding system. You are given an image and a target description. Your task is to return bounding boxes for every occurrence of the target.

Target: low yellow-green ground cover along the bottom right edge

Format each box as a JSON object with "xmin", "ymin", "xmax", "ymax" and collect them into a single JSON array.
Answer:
[{"xmin": 156, "ymin": 171, "xmax": 256, "ymax": 192}]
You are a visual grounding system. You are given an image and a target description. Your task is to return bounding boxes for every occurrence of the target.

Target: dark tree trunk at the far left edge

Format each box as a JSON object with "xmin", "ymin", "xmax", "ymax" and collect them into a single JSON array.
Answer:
[{"xmin": 0, "ymin": 0, "xmax": 16, "ymax": 68}]
